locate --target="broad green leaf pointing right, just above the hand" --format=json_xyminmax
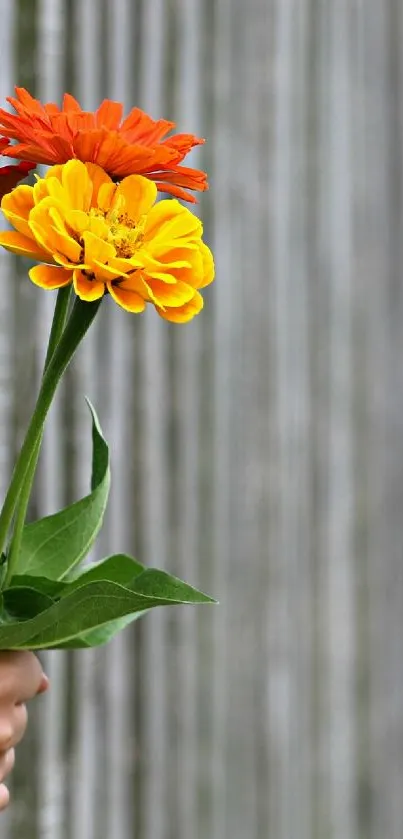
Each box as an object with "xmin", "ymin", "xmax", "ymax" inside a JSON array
[{"xmin": 0, "ymin": 555, "xmax": 214, "ymax": 650}]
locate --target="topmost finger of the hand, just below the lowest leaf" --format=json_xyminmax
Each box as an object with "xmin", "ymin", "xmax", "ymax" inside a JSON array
[{"xmin": 0, "ymin": 651, "xmax": 43, "ymax": 704}]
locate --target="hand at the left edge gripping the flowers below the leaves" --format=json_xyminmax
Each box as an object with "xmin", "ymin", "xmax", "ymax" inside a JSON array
[{"xmin": 0, "ymin": 652, "xmax": 49, "ymax": 810}]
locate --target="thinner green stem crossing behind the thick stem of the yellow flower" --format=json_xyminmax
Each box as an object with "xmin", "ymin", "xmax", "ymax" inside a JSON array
[{"xmin": 8, "ymin": 286, "xmax": 72, "ymax": 580}]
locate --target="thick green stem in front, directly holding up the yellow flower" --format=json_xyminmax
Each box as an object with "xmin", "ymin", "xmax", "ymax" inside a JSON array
[{"xmin": 0, "ymin": 297, "xmax": 101, "ymax": 588}]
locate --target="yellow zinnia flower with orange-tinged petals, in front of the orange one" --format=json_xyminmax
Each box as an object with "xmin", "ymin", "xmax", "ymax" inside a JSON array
[{"xmin": 0, "ymin": 160, "xmax": 214, "ymax": 323}]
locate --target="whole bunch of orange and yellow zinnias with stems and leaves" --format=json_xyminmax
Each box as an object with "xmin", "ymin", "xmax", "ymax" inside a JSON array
[{"xmin": 0, "ymin": 88, "xmax": 214, "ymax": 650}]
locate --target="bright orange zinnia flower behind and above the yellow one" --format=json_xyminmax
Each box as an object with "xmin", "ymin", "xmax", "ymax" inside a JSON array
[{"xmin": 0, "ymin": 87, "xmax": 207, "ymax": 203}]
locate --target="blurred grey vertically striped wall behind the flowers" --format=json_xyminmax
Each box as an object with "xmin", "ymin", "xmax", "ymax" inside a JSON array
[{"xmin": 0, "ymin": 0, "xmax": 403, "ymax": 839}]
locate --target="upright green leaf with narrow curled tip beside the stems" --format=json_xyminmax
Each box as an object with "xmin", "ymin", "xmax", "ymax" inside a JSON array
[{"xmin": 18, "ymin": 400, "xmax": 110, "ymax": 580}]
